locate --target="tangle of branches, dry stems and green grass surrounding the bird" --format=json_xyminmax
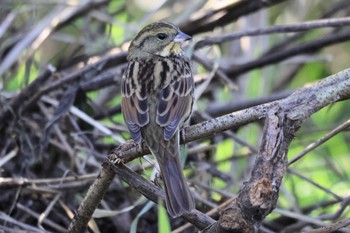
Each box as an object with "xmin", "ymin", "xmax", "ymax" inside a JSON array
[{"xmin": 0, "ymin": 0, "xmax": 350, "ymax": 233}]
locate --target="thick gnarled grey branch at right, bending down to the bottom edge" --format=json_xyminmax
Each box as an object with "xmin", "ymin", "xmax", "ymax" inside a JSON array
[{"xmin": 204, "ymin": 69, "xmax": 350, "ymax": 233}]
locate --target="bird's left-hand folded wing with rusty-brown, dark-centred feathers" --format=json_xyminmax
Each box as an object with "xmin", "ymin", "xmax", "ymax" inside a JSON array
[{"xmin": 121, "ymin": 64, "xmax": 149, "ymax": 143}]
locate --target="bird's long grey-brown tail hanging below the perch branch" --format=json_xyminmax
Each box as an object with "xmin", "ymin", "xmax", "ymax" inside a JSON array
[{"xmin": 159, "ymin": 155, "xmax": 195, "ymax": 217}]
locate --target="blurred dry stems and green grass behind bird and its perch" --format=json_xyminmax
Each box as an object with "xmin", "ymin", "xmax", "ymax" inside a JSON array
[{"xmin": 0, "ymin": 0, "xmax": 350, "ymax": 232}]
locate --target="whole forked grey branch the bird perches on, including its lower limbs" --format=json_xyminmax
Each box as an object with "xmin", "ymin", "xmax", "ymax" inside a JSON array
[{"xmin": 69, "ymin": 69, "xmax": 350, "ymax": 232}]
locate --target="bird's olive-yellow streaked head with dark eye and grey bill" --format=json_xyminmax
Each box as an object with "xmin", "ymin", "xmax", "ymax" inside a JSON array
[{"xmin": 129, "ymin": 22, "xmax": 191, "ymax": 57}]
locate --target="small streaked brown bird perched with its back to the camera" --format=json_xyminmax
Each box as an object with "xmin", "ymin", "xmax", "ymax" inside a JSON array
[{"xmin": 121, "ymin": 22, "xmax": 195, "ymax": 217}]
